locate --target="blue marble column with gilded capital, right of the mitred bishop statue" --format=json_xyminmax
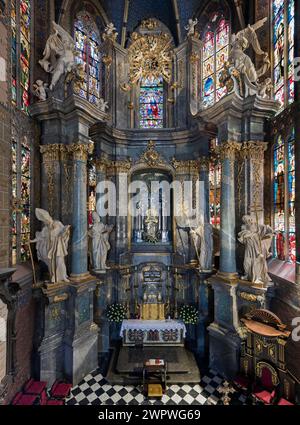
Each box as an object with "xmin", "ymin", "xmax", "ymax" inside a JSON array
[{"xmin": 67, "ymin": 143, "xmax": 92, "ymax": 280}]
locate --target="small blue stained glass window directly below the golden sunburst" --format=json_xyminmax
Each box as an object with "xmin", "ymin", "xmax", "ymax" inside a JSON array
[{"xmin": 140, "ymin": 77, "xmax": 164, "ymax": 128}]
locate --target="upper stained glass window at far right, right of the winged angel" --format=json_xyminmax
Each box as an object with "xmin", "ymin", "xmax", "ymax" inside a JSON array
[{"xmin": 273, "ymin": 0, "xmax": 295, "ymax": 107}]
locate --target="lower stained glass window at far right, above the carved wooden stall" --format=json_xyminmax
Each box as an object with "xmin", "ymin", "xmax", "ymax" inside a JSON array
[{"xmin": 273, "ymin": 131, "xmax": 296, "ymax": 262}]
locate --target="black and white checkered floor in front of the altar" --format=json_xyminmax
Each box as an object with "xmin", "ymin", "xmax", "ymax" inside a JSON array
[{"xmin": 66, "ymin": 370, "xmax": 246, "ymax": 405}]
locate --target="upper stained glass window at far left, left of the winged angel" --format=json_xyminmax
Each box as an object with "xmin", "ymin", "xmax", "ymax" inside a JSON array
[{"xmin": 11, "ymin": 0, "xmax": 31, "ymax": 113}]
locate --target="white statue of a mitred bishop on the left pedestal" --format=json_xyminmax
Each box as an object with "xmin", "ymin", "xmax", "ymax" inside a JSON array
[{"xmin": 32, "ymin": 208, "xmax": 71, "ymax": 283}]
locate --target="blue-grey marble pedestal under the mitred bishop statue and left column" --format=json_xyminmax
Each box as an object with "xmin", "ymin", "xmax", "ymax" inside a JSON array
[{"xmin": 33, "ymin": 276, "xmax": 98, "ymax": 385}]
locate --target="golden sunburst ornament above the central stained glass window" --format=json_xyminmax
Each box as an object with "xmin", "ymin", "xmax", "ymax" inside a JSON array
[{"xmin": 128, "ymin": 32, "xmax": 172, "ymax": 84}]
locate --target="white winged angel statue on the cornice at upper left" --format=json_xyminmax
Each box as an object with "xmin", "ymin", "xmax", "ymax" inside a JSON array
[{"xmin": 39, "ymin": 21, "xmax": 76, "ymax": 90}]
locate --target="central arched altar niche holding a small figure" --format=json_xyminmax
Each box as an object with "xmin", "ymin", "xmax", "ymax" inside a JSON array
[{"xmin": 131, "ymin": 170, "xmax": 173, "ymax": 248}]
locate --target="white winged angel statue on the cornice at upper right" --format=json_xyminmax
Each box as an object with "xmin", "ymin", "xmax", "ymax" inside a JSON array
[{"xmin": 229, "ymin": 18, "xmax": 271, "ymax": 85}]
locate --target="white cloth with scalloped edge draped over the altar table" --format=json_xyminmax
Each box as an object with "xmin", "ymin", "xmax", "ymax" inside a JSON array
[{"xmin": 120, "ymin": 319, "xmax": 186, "ymax": 338}]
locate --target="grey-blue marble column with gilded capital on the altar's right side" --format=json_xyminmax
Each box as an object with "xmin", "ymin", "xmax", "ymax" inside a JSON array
[{"xmin": 219, "ymin": 141, "xmax": 240, "ymax": 277}]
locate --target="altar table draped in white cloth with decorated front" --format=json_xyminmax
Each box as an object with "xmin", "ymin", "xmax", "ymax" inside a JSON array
[{"xmin": 120, "ymin": 319, "xmax": 186, "ymax": 346}]
